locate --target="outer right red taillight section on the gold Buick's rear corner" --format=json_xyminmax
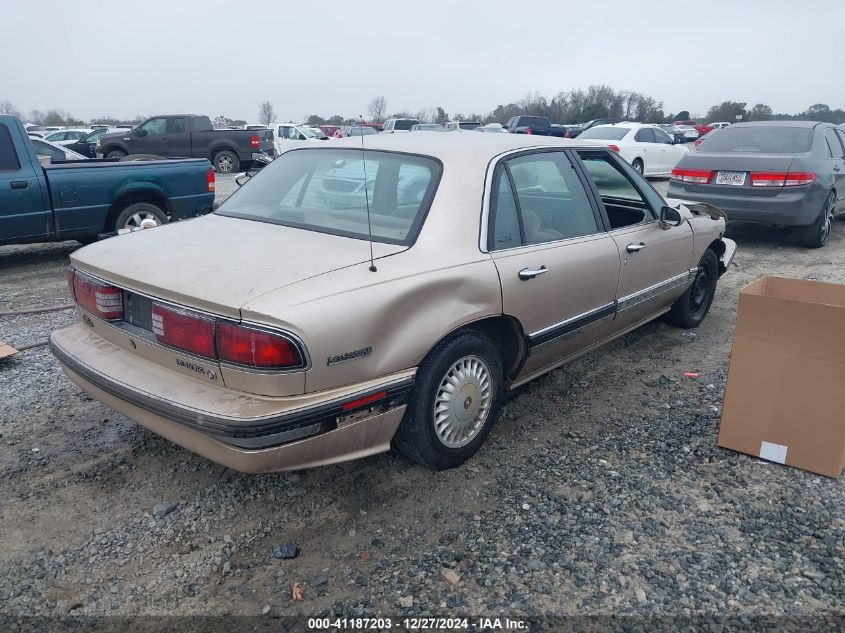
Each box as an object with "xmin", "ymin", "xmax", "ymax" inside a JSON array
[{"xmin": 217, "ymin": 321, "xmax": 303, "ymax": 369}]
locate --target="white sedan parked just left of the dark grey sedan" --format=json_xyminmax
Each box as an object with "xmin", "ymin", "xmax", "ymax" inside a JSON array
[{"xmin": 578, "ymin": 123, "xmax": 689, "ymax": 176}]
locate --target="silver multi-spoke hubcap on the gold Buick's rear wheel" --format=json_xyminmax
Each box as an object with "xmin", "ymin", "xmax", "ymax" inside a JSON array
[{"xmin": 434, "ymin": 356, "xmax": 493, "ymax": 448}]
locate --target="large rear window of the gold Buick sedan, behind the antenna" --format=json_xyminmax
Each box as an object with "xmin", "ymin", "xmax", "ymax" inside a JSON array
[{"xmin": 216, "ymin": 149, "xmax": 441, "ymax": 245}]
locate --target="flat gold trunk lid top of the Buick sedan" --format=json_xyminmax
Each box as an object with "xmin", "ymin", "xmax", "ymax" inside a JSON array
[{"xmin": 71, "ymin": 215, "xmax": 405, "ymax": 318}]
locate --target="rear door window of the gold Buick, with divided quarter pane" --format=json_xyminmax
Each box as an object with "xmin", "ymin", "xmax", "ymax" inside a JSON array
[{"xmin": 488, "ymin": 152, "xmax": 599, "ymax": 250}]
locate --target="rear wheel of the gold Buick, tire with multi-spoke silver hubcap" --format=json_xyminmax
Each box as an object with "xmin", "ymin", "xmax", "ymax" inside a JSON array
[{"xmin": 393, "ymin": 330, "xmax": 504, "ymax": 470}]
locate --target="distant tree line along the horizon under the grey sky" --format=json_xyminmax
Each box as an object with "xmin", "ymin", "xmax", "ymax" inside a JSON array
[{"xmin": 6, "ymin": 84, "xmax": 845, "ymax": 127}]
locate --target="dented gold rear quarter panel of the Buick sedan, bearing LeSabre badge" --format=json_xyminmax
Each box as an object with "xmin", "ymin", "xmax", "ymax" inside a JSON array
[{"xmin": 241, "ymin": 249, "xmax": 502, "ymax": 392}]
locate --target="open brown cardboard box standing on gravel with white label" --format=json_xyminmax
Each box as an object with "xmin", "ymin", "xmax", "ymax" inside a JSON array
[{"xmin": 718, "ymin": 277, "xmax": 845, "ymax": 477}]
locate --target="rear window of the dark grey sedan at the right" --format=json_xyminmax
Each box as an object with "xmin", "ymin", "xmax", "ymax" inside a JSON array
[{"xmin": 698, "ymin": 125, "xmax": 813, "ymax": 154}]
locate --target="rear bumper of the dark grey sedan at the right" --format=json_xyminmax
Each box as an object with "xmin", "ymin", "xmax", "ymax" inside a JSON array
[{"xmin": 667, "ymin": 181, "xmax": 824, "ymax": 226}]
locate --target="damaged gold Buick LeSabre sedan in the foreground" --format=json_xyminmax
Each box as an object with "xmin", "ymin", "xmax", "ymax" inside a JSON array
[{"xmin": 50, "ymin": 132, "xmax": 736, "ymax": 472}]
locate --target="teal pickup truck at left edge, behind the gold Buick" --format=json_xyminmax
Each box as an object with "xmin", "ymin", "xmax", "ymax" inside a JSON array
[{"xmin": 0, "ymin": 115, "xmax": 214, "ymax": 245}]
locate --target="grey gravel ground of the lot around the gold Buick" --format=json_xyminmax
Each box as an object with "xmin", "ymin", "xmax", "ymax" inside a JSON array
[{"xmin": 0, "ymin": 176, "xmax": 845, "ymax": 622}]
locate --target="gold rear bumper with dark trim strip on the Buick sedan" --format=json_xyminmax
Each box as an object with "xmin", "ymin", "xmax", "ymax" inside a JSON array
[{"xmin": 50, "ymin": 323, "xmax": 413, "ymax": 473}]
